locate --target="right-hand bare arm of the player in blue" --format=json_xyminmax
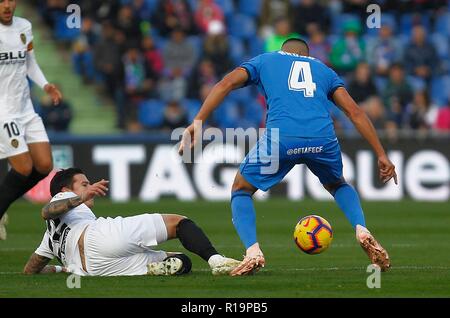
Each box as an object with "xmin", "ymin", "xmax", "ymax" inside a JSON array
[{"xmin": 333, "ymin": 87, "xmax": 397, "ymax": 184}]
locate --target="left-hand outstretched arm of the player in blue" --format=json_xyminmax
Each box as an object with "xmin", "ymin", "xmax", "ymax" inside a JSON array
[{"xmin": 178, "ymin": 68, "xmax": 248, "ymax": 154}]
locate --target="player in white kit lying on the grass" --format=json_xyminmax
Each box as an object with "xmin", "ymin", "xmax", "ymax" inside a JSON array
[{"xmin": 24, "ymin": 168, "xmax": 240, "ymax": 276}]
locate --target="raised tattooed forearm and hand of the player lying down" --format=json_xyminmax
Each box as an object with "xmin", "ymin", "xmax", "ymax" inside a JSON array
[{"xmin": 41, "ymin": 180, "xmax": 109, "ymax": 220}]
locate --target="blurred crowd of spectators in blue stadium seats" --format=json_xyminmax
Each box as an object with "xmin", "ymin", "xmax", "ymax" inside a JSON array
[{"xmin": 34, "ymin": 0, "xmax": 450, "ymax": 135}]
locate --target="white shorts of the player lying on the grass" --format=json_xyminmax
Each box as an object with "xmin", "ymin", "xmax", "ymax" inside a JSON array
[{"xmin": 84, "ymin": 214, "xmax": 167, "ymax": 276}]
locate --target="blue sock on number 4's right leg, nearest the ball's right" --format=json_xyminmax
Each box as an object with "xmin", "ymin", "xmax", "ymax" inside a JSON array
[{"xmin": 334, "ymin": 183, "xmax": 366, "ymax": 228}]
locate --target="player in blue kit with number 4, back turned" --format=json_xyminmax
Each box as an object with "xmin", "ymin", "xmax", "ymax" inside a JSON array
[{"xmin": 180, "ymin": 39, "xmax": 397, "ymax": 275}]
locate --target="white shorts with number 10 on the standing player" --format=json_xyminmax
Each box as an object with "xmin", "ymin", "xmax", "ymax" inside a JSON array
[{"xmin": 0, "ymin": 113, "xmax": 49, "ymax": 159}]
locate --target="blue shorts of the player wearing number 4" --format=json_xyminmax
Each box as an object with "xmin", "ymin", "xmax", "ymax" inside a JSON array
[{"xmin": 239, "ymin": 134, "xmax": 342, "ymax": 191}]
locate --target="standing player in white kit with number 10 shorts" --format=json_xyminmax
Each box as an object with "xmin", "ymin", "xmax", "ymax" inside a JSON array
[{"xmin": 0, "ymin": 0, "xmax": 61, "ymax": 240}]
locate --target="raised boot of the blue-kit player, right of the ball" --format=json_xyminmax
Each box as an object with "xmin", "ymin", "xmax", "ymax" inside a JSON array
[{"xmin": 356, "ymin": 224, "xmax": 391, "ymax": 272}]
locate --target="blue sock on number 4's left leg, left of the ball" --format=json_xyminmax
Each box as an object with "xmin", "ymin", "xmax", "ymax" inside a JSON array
[{"xmin": 231, "ymin": 191, "xmax": 257, "ymax": 248}]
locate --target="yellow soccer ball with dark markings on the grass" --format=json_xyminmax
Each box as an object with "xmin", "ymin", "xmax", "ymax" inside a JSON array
[{"xmin": 294, "ymin": 215, "xmax": 333, "ymax": 254}]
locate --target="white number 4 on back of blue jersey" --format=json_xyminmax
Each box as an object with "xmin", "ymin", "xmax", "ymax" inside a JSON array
[{"xmin": 289, "ymin": 61, "xmax": 316, "ymax": 97}]
